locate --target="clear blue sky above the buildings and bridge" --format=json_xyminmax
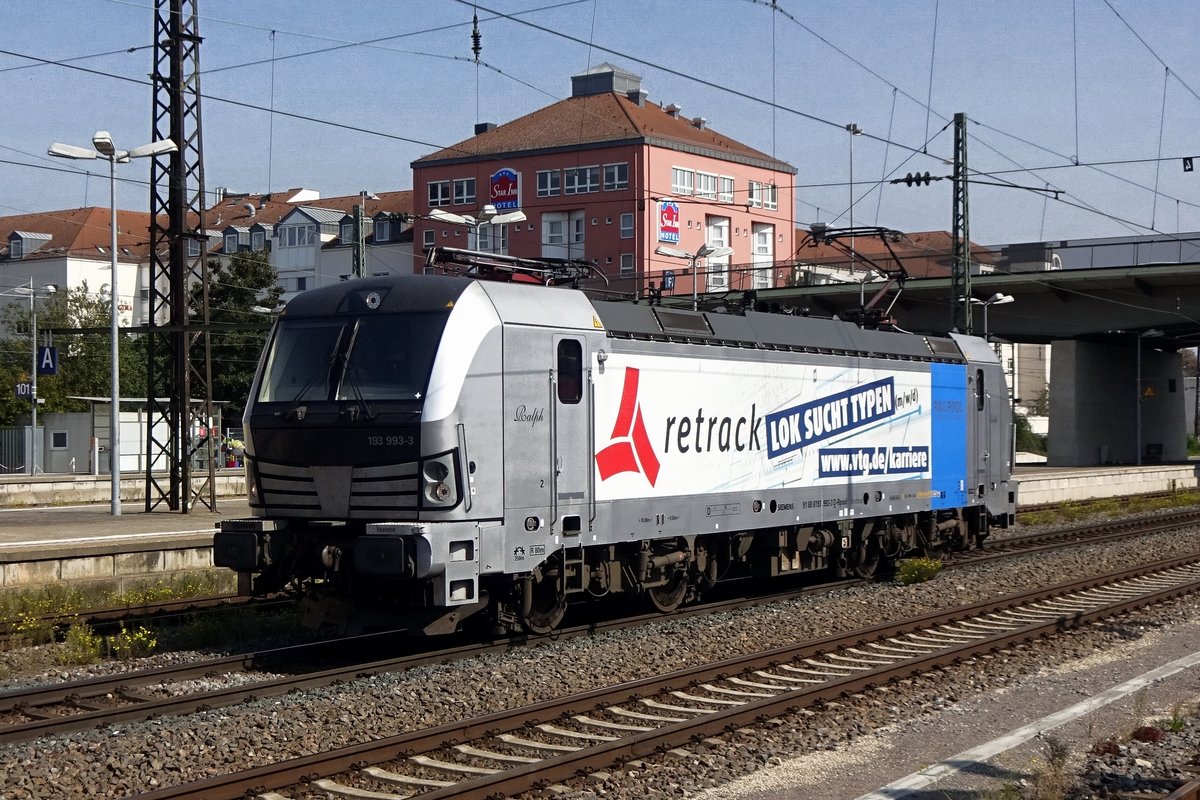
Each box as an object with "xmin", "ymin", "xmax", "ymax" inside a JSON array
[{"xmin": 0, "ymin": 0, "xmax": 1200, "ymax": 243}]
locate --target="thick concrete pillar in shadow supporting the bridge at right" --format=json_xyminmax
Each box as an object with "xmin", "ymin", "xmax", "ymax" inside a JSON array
[{"xmin": 1046, "ymin": 333, "xmax": 1188, "ymax": 467}]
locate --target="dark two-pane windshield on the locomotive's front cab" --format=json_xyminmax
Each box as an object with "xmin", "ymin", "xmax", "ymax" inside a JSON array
[{"xmin": 258, "ymin": 312, "xmax": 446, "ymax": 403}]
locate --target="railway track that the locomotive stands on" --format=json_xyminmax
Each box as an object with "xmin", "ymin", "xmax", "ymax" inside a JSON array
[{"xmin": 0, "ymin": 512, "xmax": 1200, "ymax": 744}]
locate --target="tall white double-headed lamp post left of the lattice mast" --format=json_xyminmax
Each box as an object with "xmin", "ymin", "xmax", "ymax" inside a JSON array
[{"xmin": 47, "ymin": 131, "xmax": 179, "ymax": 517}]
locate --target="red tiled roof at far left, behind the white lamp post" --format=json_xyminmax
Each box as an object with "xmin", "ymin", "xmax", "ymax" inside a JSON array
[{"xmin": 0, "ymin": 207, "xmax": 150, "ymax": 263}]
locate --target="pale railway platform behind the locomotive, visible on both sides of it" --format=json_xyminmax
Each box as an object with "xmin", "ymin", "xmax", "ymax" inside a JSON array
[{"xmin": 0, "ymin": 463, "xmax": 1200, "ymax": 590}]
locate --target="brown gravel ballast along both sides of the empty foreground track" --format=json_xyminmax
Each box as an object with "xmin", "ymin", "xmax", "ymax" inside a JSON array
[{"xmin": 0, "ymin": 513, "xmax": 1198, "ymax": 800}]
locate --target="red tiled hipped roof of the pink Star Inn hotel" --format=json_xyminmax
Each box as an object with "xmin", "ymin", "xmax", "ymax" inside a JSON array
[{"xmin": 413, "ymin": 92, "xmax": 794, "ymax": 172}]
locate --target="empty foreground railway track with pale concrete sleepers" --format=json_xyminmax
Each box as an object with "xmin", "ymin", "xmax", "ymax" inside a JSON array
[{"xmin": 124, "ymin": 553, "xmax": 1200, "ymax": 800}]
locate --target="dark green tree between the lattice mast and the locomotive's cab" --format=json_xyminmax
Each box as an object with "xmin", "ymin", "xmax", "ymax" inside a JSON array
[{"xmin": 193, "ymin": 251, "xmax": 283, "ymax": 425}]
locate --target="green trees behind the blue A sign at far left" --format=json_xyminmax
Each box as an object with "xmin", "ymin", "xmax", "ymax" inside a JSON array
[{"xmin": 0, "ymin": 282, "xmax": 145, "ymax": 425}]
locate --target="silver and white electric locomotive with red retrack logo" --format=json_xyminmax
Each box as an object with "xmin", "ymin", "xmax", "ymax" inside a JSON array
[{"xmin": 214, "ymin": 250, "xmax": 1015, "ymax": 633}]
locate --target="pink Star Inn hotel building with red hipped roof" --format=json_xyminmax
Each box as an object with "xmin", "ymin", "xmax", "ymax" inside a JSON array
[{"xmin": 412, "ymin": 64, "xmax": 796, "ymax": 294}]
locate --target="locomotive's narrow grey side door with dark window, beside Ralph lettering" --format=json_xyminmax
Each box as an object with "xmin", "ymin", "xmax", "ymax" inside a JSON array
[{"xmin": 550, "ymin": 336, "xmax": 595, "ymax": 536}]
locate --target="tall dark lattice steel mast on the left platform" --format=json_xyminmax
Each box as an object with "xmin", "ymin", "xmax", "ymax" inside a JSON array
[{"xmin": 145, "ymin": 0, "xmax": 216, "ymax": 513}]
